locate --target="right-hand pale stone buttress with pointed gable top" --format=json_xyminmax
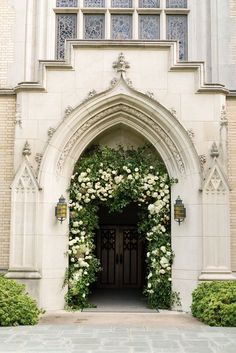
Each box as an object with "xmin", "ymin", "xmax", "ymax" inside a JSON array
[{"xmin": 200, "ymin": 158, "xmax": 234, "ymax": 280}]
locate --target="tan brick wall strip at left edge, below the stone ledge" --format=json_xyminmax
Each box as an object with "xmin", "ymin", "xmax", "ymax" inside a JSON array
[{"xmin": 0, "ymin": 95, "xmax": 15, "ymax": 270}]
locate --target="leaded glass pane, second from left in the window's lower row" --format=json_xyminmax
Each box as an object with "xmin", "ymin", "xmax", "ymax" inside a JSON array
[{"xmin": 84, "ymin": 14, "xmax": 105, "ymax": 39}]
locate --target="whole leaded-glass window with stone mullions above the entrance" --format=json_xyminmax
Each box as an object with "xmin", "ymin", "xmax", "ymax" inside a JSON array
[{"xmin": 54, "ymin": 0, "xmax": 189, "ymax": 60}]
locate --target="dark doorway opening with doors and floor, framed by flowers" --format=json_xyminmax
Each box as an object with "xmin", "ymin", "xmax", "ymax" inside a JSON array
[{"xmin": 88, "ymin": 204, "xmax": 149, "ymax": 312}]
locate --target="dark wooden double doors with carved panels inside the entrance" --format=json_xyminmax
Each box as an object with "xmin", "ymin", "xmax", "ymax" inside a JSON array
[{"xmin": 97, "ymin": 225, "xmax": 143, "ymax": 288}]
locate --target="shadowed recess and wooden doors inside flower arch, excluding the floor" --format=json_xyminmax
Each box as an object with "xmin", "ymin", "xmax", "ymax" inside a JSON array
[{"xmin": 96, "ymin": 204, "xmax": 145, "ymax": 289}]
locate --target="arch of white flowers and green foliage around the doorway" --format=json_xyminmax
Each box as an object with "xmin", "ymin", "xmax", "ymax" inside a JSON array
[{"xmin": 66, "ymin": 145, "xmax": 173, "ymax": 309}]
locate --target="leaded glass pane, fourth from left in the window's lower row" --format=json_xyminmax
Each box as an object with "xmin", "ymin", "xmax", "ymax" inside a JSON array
[{"xmin": 139, "ymin": 15, "xmax": 160, "ymax": 40}]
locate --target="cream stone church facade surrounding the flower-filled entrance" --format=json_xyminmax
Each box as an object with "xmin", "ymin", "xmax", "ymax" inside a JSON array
[{"xmin": 0, "ymin": 0, "xmax": 236, "ymax": 310}]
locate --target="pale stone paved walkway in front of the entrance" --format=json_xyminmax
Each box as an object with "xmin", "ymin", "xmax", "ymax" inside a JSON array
[{"xmin": 0, "ymin": 312, "xmax": 236, "ymax": 353}]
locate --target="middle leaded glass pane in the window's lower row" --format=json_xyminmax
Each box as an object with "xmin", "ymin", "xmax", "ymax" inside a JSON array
[{"xmin": 111, "ymin": 15, "xmax": 132, "ymax": 40}]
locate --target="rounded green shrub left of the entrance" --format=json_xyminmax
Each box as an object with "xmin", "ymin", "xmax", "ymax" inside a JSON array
[{"xmin": 0, "ymin": 276, "xmax": 42, "ymax": 326}]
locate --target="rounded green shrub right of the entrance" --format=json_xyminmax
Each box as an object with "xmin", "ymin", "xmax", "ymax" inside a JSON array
[{"xmin": 192, "ymin": 281, "xmax": 236, "ymax": 327}]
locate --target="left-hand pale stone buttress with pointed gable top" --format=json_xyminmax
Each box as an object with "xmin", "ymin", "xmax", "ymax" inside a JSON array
[{"xmin": 7, "ymin": 157, "xmax": 41, "ymax": 278}]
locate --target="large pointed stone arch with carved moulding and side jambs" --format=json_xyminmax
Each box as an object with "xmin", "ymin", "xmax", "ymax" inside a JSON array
[{"xmin": 30, "ymin": 77, "xmax": 205, "ymax": 310}]
